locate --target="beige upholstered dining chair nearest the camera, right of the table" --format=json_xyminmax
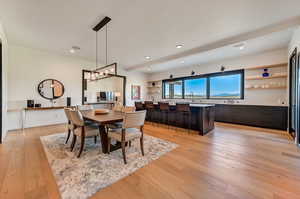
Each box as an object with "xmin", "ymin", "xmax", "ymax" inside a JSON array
[{"xmin": 107, "ymin": 110, "xmax": 146, "ymax": 164}]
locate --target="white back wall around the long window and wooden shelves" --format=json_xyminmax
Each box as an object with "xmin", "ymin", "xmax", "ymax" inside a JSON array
[{"xmin": 148, "ymin": 49, "xmax": 288, "ymax": 106}]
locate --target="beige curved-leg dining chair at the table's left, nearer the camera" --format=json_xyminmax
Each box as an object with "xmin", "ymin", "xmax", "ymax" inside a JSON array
[{"xmin": 69, "ymin": 110, "xmax": 99, "ymax": 158}]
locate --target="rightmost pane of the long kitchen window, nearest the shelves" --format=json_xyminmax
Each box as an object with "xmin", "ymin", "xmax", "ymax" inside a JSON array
[{"xmin": 209, "ymin": 74, "xmax": 242, "ymax": 99}]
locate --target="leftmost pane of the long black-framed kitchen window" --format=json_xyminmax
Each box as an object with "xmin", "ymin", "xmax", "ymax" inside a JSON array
[{"xmin": 163, "ymin": 80, "xmax": 182, "ymax": 99}]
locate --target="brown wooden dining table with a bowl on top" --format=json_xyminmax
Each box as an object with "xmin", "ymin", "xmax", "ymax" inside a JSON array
[{"xmin": 81, "ymin": 110, "xmax": 124, "ymax": 153}]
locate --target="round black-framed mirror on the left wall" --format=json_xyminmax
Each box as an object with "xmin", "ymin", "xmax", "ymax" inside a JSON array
[{"xmin": 38, "ymin": 79, "xmax": 65, "ymax": 100}]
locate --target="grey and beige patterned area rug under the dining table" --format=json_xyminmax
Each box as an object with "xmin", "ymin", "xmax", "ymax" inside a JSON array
[{"xmin": 40, "ymin": 133, "xmax": 177, "ymax": 199}]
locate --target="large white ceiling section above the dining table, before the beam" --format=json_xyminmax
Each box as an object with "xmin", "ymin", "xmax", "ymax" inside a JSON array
[{"xmin": 0, "ymin": 0, "xmax": 300, "ymax": 70}]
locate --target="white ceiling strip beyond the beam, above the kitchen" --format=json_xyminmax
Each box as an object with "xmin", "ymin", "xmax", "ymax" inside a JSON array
[{"xmin": 142, "ymin": 28, "xmax": 294, "ymax": 73}]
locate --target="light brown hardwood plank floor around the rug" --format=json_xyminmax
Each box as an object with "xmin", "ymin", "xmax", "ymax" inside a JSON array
[{"xmin": 0, "ymin": 123, "xmax": 300, "ymax": 199}]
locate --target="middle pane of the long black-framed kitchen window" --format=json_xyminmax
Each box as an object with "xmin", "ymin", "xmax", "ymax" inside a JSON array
[{"xmin": 184, "ymin": 78, "xmax": 207, "ymax": 99}]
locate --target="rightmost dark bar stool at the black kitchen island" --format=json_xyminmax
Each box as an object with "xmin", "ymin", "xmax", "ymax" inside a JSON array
[{"xmin": 176, "ymin": 103, "xmax": 192, "ymax": 132}]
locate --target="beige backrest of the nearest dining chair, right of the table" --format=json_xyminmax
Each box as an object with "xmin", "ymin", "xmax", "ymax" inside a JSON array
[{"xmin": 123, "ymin": 110, "xmax": 146, "ymax": 129}]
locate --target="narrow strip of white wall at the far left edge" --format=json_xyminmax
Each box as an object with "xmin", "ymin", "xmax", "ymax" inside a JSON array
[{"xmin": 0, "ymin": 23, "xmax": 8, "ymax": 140}]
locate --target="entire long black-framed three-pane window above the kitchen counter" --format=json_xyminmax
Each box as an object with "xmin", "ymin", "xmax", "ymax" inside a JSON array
[{"xmin": 163, "ymin": 70, "xmax": 244, "ymax": 99}]
